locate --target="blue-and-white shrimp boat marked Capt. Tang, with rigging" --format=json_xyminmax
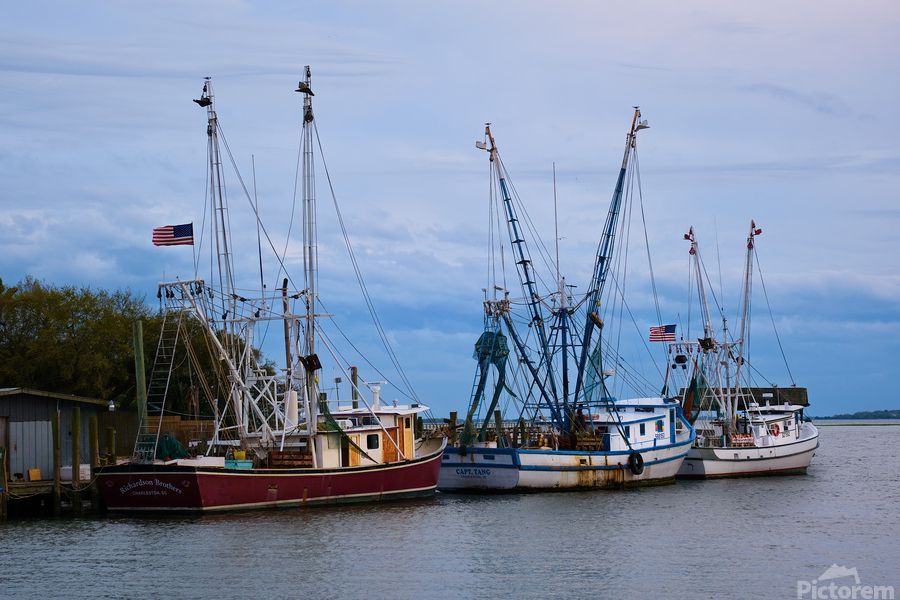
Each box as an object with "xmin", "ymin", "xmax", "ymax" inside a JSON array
[{"xmin": 438, "ymin": 108, "xmax": 694, "ymax": 492}]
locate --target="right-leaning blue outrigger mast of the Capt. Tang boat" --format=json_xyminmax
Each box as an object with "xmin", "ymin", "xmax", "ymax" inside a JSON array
[{"xmin": 574, "ymin": 106, "xmax": 649, "ymax": 400}]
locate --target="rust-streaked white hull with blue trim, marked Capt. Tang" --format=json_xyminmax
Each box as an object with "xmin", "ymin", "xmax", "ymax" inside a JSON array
[{"xmin": 438, "ymin": 435, "xmax": 693, "ymax": 493}]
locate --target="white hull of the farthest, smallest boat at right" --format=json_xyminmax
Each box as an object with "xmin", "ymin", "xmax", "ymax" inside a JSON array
[{"xmin": 677, "ymin": 433, "xmax": 819, "ymax": 479}]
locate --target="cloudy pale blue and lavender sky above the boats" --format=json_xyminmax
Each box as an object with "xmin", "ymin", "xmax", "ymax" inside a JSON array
[{"xmin": 0, "ymin": 0, "xmax": 900, "ymax": 415}]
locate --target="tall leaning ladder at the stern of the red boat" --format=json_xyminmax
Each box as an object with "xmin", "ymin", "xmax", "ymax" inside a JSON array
[{"xmin": 134, "ymin": 310, "xmax": 185, "ymax": 463}]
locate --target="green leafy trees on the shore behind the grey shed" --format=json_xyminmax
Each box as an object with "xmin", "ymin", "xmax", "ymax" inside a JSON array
[{"xmin": 0, "ymin": 277, "xmax": 250, "ymax": 415}]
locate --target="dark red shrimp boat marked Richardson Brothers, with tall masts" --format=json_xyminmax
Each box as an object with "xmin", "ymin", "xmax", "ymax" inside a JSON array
[{"xmin": 98, "ymin": 67, "xmax": 446, "ymax": 511}]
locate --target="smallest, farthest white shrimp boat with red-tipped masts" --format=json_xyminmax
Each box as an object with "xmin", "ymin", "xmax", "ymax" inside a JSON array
[{"xmin": 669, "ymin": 222, "xmax": 819, "ymax": 479}]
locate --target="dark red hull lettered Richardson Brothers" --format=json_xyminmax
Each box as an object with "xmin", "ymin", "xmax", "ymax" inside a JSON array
[{"xmin": 97, "ymin": 442, "xmax": 445, "ymax": 512}]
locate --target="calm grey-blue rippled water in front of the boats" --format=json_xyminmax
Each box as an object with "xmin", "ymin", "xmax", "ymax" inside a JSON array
[{"xmin": 0, "ymin": 426, "xmax": 900, "ymax": 599}]
